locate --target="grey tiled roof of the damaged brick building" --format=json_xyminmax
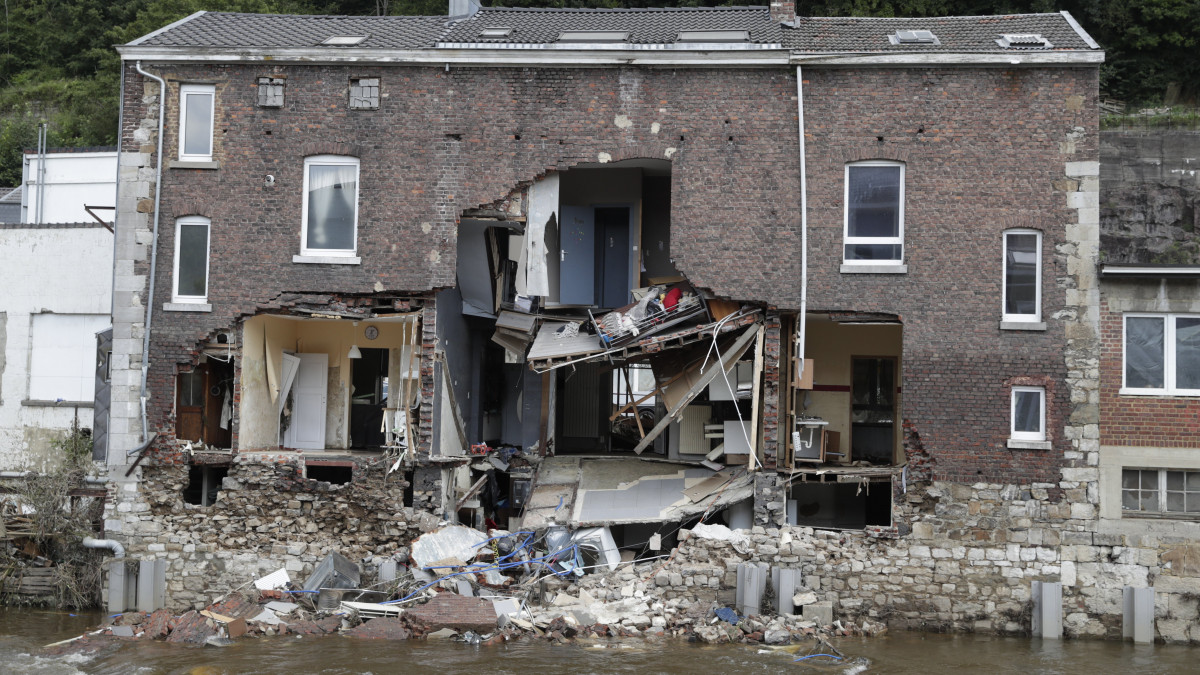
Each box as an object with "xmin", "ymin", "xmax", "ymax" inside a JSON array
[{"xmin": 124, "ymin": 7, "xmax": 1090, "ymax": 53}]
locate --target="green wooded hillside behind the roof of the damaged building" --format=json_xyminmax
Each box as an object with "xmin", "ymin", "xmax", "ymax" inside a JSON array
[{"xmin": 0, "ymin": 0, "xmax": 1200, "ymax": 185}]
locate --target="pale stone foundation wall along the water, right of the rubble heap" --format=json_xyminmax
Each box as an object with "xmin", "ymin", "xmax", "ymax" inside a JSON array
[{"xmin": 568, "ymin": 480, "xmax": 1200, "ymax": 643}]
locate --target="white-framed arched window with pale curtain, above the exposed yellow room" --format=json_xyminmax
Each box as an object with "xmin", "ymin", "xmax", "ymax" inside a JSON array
[{"xmin": 300, "ymin": 155, "xmax": 359, "ymax": 257}]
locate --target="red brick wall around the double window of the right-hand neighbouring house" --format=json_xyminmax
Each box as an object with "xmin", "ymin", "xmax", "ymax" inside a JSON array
[{"xmin": 1100, "ymin": 294, "xmax": 1200, "ymax": 448}]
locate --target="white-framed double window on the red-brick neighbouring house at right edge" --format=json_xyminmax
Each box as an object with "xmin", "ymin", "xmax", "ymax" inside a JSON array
[{"xmin": 1121, "ymin": 313, "xmax": 1200, "ymax": 396}]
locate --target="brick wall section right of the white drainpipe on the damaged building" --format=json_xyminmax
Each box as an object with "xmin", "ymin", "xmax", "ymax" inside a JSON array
[{"xmin": 804, "ymin": 68, "xmax": 1098, "ymax": 482}]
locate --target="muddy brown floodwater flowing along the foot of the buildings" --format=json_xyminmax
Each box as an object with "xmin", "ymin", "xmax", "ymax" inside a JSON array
[{"xmin": 0, "ymin": 609, "xmax": 1200, "ymax": 675}]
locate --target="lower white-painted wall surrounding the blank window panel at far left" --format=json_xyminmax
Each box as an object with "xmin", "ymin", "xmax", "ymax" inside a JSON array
[{"xmin": 0, "ymin": 226, "xmax": 113, "ymax": 471}]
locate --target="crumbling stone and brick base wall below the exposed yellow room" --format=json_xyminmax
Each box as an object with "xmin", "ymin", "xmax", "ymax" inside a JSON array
[{"xmin": 106, "ymin": 453, "xmax": 438, "ymax": 609}]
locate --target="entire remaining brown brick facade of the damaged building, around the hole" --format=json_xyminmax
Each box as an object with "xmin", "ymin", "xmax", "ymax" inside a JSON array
[{"xmin": 124, "ymin": 57, "xmax": 1097, "ymax": 480}]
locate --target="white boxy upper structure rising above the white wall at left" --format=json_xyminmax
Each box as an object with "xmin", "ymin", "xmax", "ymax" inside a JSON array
[{"xmin": 22, "ymin": 150, "xmax": 116, "ymax": 223}]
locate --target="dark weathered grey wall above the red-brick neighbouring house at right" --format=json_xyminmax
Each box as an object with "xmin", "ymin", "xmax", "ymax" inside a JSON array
[{"xmin": 1100, "ymin": 129, "xmax": 1200, "ymax": 264}]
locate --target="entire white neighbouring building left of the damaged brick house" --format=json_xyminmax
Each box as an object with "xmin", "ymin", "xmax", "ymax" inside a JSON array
[{"xmin": 0, "ymin": 151, "xmax": 116, "ymax": 471}]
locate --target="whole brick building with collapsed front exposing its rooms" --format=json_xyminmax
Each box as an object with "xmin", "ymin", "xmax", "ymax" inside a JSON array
[{"xmin": 107, "ymin": 0, "xmax": 1142, "ymax": 634}]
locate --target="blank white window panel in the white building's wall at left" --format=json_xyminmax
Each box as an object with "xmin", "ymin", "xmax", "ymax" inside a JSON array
[{"xmin": 29, "ymin": 313, "xmax": 110, "ymax": 404}]
